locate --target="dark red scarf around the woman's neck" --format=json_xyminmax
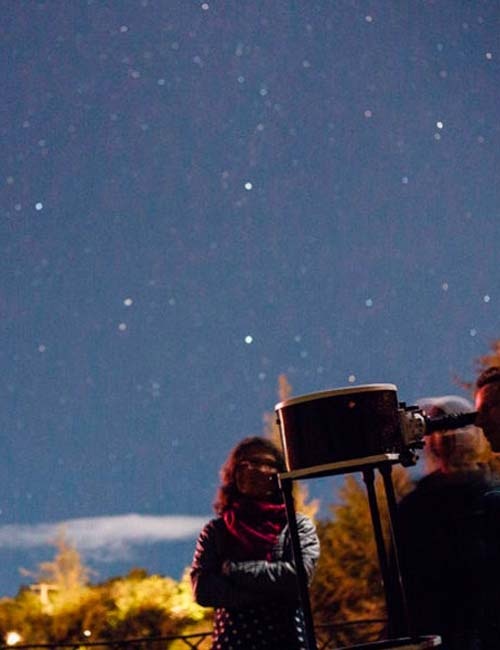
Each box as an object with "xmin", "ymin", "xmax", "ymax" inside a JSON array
[{"xmin": 222, "ymin": 499, "xmax": 286, "ymax": 560}]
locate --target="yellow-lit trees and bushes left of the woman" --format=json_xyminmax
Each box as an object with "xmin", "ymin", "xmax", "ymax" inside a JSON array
[{"xmin": 0, "ymin": 535, "xmax": 210, "ymax": 644}]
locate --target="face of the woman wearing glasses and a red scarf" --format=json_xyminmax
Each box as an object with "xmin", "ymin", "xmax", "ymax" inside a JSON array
[{"xmin": 235, "ymin": 447, "xmax": 278, "ymax": 499}]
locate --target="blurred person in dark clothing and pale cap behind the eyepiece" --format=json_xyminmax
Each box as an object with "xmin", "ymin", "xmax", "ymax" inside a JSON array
[{"xmin": 398, "ymin": 396, "xmax": 500, "ymax": 650}]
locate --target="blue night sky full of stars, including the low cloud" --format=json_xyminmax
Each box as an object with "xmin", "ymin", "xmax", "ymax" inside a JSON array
[{"xmin": 0, "ymin": 0, "xmax": 500, "ymax": 595}]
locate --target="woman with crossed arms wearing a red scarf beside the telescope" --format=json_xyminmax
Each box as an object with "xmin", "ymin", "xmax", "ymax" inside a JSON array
[{"xmin": 191, "ymin": 437, "xmax": 319, "ymax": 650}]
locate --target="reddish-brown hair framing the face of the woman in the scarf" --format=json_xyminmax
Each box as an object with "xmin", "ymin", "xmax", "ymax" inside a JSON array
[{"xmin": 214, "ymin": 436, "xmax": 286, "ymax": 515}]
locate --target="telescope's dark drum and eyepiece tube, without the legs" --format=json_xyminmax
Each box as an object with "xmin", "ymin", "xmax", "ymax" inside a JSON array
[{"xmin": 275, "ymin": 384, "xmax": 477, "ymax": 471}]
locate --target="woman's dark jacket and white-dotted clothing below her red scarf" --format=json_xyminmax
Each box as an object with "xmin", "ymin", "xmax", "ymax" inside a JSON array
[{"xmin": 191, "ymin": 514, "xmax": 319, "ymax": 650}]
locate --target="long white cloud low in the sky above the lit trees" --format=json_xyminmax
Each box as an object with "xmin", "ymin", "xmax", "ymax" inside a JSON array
[{"xmin": 0, "ymin": 514, "xmax": 208, "ymax": 561}]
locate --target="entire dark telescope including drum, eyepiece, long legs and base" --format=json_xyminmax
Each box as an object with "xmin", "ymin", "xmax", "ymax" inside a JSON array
[{"xmin": 275, "ymin": 384, "xmax": 458, "ymax": 650}]
